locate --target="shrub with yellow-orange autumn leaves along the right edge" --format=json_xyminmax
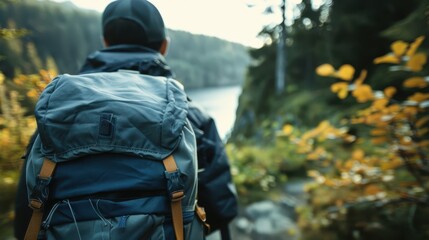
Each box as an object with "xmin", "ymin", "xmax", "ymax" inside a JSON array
[{"xmin": 283, "ymin": 37, "xmax": 429, "ymax": 240}]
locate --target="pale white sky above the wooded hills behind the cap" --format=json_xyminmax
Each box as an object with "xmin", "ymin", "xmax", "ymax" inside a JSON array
[{"xmin": 50, "ymin": 0, "xmax": 300, "ymax": 47}]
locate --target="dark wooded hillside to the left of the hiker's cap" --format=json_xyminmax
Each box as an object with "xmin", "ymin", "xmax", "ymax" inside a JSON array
[{"xmin": 0, "ymin": 1, "xmax": 102, "ymax": 78}]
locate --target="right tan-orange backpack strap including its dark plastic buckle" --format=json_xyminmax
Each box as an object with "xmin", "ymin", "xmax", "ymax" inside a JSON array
[{"xmin": 162, "ymin": 155, "xmax": 185, "ymax": 240}]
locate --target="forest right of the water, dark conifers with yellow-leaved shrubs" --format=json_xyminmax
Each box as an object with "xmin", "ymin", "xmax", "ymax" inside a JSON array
[{"xmin": 228, "ymin": 0, "xmax": 429, "ymax": 240}]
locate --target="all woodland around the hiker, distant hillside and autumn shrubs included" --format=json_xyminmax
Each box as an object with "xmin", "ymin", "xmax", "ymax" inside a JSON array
[{"xmin": 0, "ymin": 0, "xmax": 429, "ymax": 240}]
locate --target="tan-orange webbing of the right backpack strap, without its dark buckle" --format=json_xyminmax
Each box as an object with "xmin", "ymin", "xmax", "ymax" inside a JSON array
[{"xmin": 162, "ymin": 155, "xmax": 185, "ymax": 240}]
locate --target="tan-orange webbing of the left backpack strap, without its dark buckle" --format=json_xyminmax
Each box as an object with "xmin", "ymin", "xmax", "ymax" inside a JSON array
[{"xmin": 24, "ymin": 158, "xmax": 56, "ymax": 240}]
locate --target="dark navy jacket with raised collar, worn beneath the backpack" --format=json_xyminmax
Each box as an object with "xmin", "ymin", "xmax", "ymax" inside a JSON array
[{"xmin": 15, "ymin": 45, "xmax": 238, "ymax": 239}]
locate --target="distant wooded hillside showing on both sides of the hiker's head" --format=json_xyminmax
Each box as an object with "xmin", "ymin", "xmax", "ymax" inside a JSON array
[{"xmin": 0, "ymin": 0, "xmax": 249, "ymax": 88}]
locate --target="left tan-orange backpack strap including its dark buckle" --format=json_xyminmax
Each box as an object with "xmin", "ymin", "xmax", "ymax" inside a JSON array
[{"xmin": 24, "ymin": 158, "xmax": 56, "ymax": 240}]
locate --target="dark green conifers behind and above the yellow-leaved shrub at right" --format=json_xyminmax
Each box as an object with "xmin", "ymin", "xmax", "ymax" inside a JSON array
[{"xmin": 231, "ymin": 0, "xmax": 422, "ymax": 141}]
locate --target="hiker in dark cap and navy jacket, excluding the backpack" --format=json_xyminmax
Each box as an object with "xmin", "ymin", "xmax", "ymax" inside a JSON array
[{"xmin": 14, "ymin": 0, "xmax": 238, "ymax": 240}]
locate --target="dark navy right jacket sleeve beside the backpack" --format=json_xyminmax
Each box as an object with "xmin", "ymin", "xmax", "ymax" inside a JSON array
[{"xmin": 188, "ymin": 102, "xmax": 238, "ymax": 230}]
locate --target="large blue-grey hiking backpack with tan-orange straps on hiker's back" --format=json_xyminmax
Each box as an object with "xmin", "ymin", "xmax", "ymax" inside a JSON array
[{"xmin": 25, "ymin": 71, "xmax": 206, "ymax": 240}]
